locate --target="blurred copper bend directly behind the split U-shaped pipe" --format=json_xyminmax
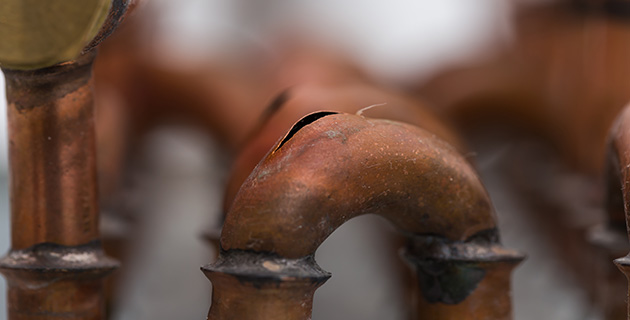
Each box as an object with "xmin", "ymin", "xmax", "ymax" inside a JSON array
[{"xmin": 220, "ymin": 79, "xmax": 465, "ymax": 234}]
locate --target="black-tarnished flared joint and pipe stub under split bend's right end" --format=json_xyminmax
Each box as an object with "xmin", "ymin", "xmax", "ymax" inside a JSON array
[{"xmin": 405, "ymin": 232, "xmax": 523, "ymax": 320}]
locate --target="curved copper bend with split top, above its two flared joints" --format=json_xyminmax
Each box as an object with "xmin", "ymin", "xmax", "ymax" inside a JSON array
[{"xmin": 221, "ymin": 112, "xmax": 496, "ymax": 258}]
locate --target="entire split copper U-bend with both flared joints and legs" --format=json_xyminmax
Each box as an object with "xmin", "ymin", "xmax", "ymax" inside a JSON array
[{"xmin": 202, "ymin": 112, "xmax": 522, "ymax": 320}]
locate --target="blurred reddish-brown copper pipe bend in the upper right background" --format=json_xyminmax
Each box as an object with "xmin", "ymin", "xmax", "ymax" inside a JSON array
[{"xmin": 419, "ymin": 0, "xmax": 630, "ymax": 177}]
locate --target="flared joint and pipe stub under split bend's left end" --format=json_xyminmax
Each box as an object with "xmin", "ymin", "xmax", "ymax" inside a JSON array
[{"xmin": 201, "ymin": 250, "xmax": 330, "ymax": 320}]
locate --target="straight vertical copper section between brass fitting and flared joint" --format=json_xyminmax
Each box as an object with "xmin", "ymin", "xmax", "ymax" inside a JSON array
[{"xmin": 5, "ymin": 54, "xmax": 98, "ymax": 250}]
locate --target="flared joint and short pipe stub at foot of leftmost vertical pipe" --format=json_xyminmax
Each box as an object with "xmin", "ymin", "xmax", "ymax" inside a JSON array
[{"xmin": 0, "ymin": 241, "xmax": 118, "ymax": 320}]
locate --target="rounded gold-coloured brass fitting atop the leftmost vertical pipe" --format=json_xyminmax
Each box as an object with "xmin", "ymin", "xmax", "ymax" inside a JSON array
[{"xmin": 0, "ymin": 0, "xmax": 111, "ymax": 69}]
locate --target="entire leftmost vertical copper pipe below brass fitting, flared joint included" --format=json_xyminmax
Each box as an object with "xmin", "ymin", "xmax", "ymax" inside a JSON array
[{"xmin": 0, "ymin": 0, "xmax": 128, "ymax": 320}]
